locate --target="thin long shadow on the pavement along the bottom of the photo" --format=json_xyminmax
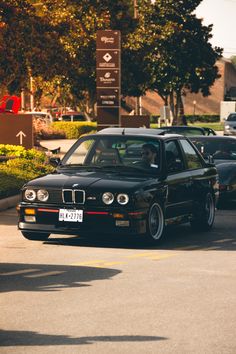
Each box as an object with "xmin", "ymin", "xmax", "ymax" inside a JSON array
[{"xmin": 0, "ymin": 330, "xmax": 168, "ymax": 347}]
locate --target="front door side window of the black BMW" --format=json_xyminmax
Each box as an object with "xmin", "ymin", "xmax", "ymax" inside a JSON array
[{"xmin": 165, "ymin": 140, "xmax": 184, "ymax": 173}]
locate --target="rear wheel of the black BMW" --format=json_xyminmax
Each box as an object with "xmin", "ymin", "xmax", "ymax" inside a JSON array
[{"xmin": 190, "ymin": 192, "xmax": 215, "ymax": 231}]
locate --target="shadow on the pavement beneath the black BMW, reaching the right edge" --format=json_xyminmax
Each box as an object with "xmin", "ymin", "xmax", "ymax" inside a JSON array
[{"xmin": 44, "ymin": 211, "xmax": 236, "ymax": 251}]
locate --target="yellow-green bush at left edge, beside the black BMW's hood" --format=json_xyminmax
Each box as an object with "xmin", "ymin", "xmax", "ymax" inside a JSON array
[{"xmin": 0, "ymin": 144, "xmax": 54, "ymax": 199}]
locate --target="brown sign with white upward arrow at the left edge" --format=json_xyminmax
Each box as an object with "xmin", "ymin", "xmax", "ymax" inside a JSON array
[{"xmin": 0, "ymin": 113, "xmax": 33, "ymax": 149}]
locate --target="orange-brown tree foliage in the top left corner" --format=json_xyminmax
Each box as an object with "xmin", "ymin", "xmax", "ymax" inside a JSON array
[{"xmin": 0, "ymin": 0, "xmax": 69, "ymax": 93}]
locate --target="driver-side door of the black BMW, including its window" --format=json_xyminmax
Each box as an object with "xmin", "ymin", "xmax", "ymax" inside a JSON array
[{"xmin": 164, "ymin": 139, "xmax": 192, "ymax": 219}]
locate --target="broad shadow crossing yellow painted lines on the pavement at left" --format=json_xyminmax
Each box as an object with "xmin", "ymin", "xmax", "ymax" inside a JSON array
[{"xmin": 0, "ymin": 263, "xmax": 121, "ymax": 293}]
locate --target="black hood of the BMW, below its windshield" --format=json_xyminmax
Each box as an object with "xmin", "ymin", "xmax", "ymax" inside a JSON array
[{"xmin": 25, "ymin": 171, "xmax": 157, "ymax": 191}]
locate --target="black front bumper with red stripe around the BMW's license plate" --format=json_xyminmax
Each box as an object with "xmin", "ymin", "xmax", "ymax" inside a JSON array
[{"xmin": 17, "ymin": 203, "xmax": 147, "ymax": 235}]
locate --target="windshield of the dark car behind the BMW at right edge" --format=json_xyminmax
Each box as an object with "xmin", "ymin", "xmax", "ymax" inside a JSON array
[{"xmin": 191, "ymin": 139, "xmax": 236, "ymax": 160}]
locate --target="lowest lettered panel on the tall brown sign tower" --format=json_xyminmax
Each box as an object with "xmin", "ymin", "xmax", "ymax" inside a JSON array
[{"xmin": 97, "ymin": 88, "xmax": 120, "ymax": 107}]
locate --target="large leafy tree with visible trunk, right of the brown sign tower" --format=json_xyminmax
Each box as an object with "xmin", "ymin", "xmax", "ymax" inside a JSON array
[{"xmin": 142, "ymin": 0, "xmax": 222, "ymax": 123}]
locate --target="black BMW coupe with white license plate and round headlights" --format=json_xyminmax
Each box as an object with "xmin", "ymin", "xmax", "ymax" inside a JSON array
[{"xmin": 18, "ymin": 128, "xmax": 218, "ymax": 241}]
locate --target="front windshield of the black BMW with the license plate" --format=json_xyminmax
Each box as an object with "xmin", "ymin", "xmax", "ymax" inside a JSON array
[{"xmin": 61, "ymin": 135, "xmax": 160, "ymax": 173}]
